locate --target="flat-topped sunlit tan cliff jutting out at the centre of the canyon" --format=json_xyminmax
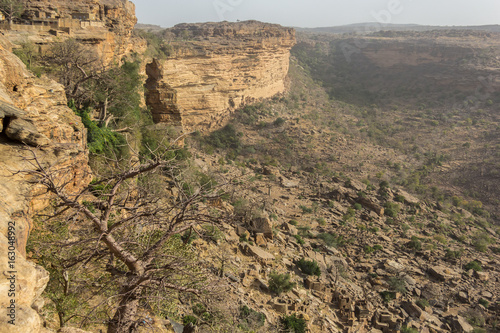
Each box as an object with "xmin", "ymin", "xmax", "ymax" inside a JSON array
[{"xmin": 146, "ymin": 21, "xmax": 295, "ymax": 130}]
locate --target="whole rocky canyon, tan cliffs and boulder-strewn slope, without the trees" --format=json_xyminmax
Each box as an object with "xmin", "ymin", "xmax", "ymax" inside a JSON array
[{"xmin": 0, "ymin": 0, "xmax": 500, "ymax": 333}]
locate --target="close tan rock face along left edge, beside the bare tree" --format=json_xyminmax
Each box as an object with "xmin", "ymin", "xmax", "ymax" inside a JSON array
[{"xmin": 0, "ymin": 37, "xmax": 90, "ymax": 333}]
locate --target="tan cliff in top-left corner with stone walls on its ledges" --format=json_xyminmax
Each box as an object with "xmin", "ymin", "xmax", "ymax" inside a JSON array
[{"xmin": 5, "ymin": 0, "xmax": 145, "ymax": 64}]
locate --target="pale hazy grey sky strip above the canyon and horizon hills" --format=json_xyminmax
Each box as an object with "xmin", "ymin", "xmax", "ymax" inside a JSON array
[{"xmin": 132, "ymin": 0, "xmax": 500, "ymax": 27}]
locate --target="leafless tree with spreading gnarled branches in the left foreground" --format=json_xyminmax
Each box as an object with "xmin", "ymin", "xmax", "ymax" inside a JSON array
[{"xmin": 23, "ymin": 141, "xmax": 227, "ymax": 333}]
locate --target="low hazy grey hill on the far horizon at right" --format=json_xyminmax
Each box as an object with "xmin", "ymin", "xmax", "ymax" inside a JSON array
[{"xmin": 295, "ymin": 22, "xmax": 500, "ymax": 34}]
